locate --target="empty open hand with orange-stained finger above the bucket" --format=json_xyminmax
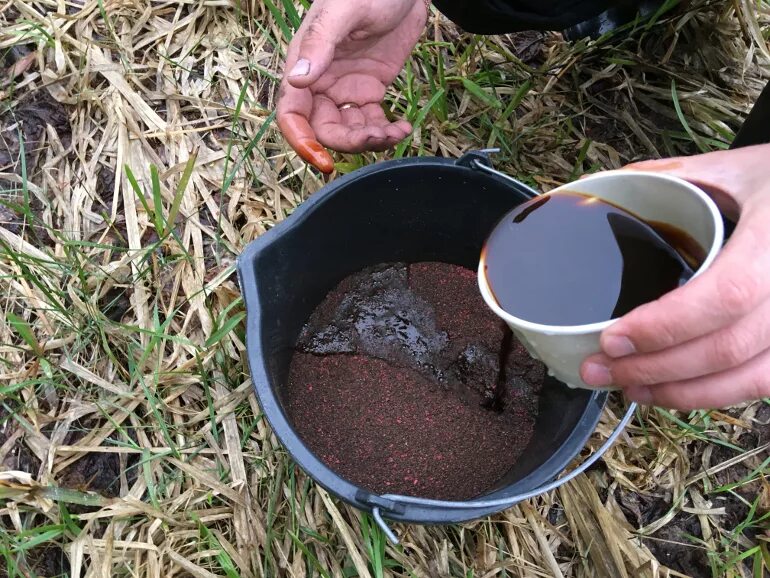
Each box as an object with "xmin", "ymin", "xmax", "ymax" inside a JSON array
[{"xmin": 277, "ymin": 0, "xmax": 427, "ymax": 173}]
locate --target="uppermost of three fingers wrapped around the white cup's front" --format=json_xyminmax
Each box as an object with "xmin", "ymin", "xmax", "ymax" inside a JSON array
[{"xmin": 600, "ymin": 199, "xmax": 770, "ymax": 358}]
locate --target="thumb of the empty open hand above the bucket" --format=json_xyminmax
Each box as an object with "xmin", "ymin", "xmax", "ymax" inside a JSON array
[{"xmin": 287, "ymin": 1, "xmax": 361, "ymax": 88}]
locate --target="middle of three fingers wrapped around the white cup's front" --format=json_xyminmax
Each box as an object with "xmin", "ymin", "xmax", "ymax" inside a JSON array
[{"xmin": 582, "ymin": 300, "xmax": 770, "ymax": 388}]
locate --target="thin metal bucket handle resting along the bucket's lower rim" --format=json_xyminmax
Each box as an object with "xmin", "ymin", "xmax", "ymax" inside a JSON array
[{"xmin": 372, "ymin": 402, "xmax": 637, "ymax": 545}]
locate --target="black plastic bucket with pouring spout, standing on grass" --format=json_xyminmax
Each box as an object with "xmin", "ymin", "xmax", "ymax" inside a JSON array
[{"xmin": 238, "ymin": 153, "xmax": 624, "ymax": 524}]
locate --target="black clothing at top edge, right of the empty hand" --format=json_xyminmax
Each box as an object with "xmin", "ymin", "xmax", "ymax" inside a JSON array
[{"xmin": 433, "ymin": 0, "xmax": 610, "ymax": 34}]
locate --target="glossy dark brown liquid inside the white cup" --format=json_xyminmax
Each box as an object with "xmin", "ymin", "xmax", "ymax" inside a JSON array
[{"xmin": 482, "ymin": 192, "xmax": 706, "ymax": 325}]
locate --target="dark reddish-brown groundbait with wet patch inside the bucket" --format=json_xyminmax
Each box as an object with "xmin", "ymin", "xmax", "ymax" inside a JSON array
[{"xmin": 284, "ymin": 263, "xmax": 544, "ymax": 500}]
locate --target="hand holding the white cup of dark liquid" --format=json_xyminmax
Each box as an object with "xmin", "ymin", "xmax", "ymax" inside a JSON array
[{"xmin": 581, "ymin": 145, "xmax": 770, "ymax": 410}]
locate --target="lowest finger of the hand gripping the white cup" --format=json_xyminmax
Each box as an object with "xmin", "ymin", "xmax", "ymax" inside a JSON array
[{"xmin": 625, "ymin": 351, "xmax": 770, "ymax": 411}]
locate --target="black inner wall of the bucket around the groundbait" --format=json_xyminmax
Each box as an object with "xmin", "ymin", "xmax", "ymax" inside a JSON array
[{"xmin": 242, "ymin": 159, "xmax": 604, "ymax": 519}]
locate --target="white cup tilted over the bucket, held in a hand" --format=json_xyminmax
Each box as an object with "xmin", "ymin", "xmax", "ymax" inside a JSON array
[{"xmin": 478, "ymin": 170, "xmax": 724, "ymax": 389}]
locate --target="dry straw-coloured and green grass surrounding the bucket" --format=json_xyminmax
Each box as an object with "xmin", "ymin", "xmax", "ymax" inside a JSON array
[{"xmin": 0, "ymin": 0, "xmax": 770, "ymax": 578}]
